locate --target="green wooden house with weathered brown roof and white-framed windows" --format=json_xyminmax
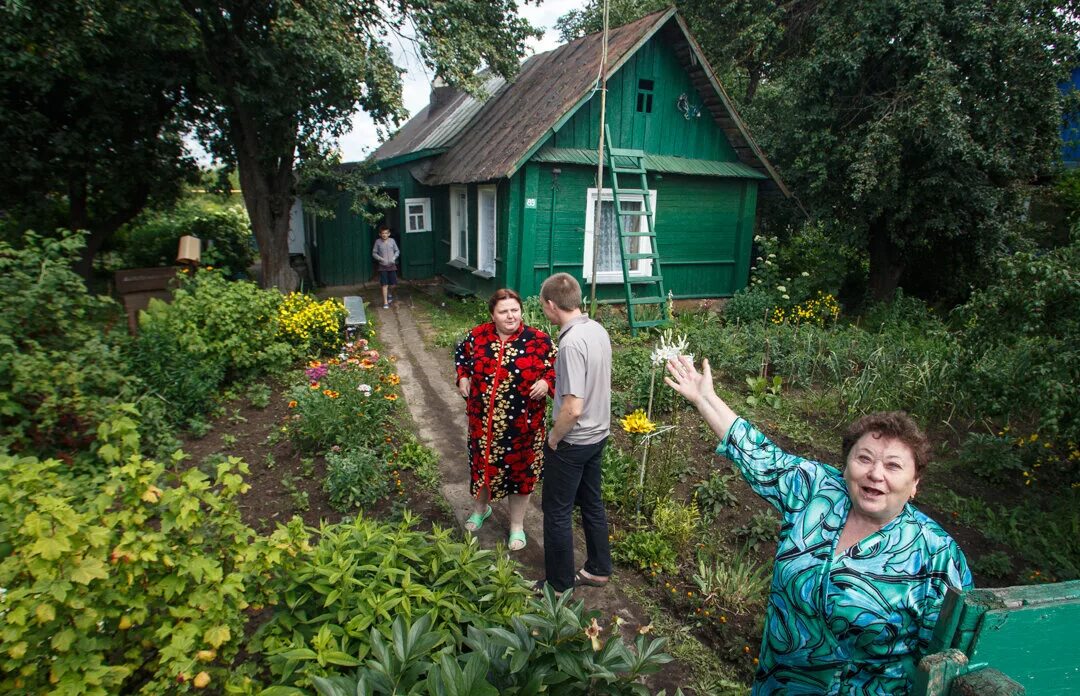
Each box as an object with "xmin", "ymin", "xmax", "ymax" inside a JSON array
[{"xmin": 308, "ymin": 9, "xmax": 787, "ymax": 299}]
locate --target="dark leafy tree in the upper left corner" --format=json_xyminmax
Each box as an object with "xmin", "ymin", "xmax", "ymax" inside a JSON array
[{"xmin": 0, "ymin": 0, "xmax": 195, "ymax": 278}]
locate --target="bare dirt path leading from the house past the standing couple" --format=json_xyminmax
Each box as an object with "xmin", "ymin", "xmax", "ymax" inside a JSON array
[{"xmin": 334, "ymin": 285, "xmax": 648, "ymax": 629}]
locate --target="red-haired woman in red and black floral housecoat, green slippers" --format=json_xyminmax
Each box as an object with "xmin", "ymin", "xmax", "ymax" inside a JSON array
[{"xmin": 456, "ymin": 290, "xmax": 555, "ymax": 551}]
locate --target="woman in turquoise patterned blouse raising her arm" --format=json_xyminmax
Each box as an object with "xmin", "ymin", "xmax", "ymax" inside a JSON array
[{"xmin": 665, "ymin": 357, "xmax": 972, "ymax": 695}]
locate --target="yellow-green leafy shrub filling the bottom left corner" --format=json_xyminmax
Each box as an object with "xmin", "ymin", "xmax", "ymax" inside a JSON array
[{"xmin": 0, "ymin": 420, "xmax": 293, "ymax": 694}]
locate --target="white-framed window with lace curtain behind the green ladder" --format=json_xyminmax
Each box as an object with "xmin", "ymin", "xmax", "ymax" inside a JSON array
[{"xmin": 583, "ymin": 188, "xmax": 657, "ymax": 283}]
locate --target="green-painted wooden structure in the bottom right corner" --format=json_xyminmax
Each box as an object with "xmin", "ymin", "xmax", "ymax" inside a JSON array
[{"xmin": 913, "ymin": 580, "xmax": 1080, "ymax": 696}]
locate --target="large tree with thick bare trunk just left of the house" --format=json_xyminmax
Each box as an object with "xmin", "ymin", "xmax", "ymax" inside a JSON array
[{"xmin": 178, "ymin": 0, "xmax": 544, "ymax": 290}]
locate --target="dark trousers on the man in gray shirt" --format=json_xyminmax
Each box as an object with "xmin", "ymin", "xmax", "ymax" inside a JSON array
[{"xmin": 541, "ymin": 438, "xmax": 611, "ymax": 592}]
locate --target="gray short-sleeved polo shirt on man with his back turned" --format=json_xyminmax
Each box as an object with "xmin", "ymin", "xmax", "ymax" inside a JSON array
[{"xmin": 552, "ymin": 314, "xmax": 611, "ymax": 444}]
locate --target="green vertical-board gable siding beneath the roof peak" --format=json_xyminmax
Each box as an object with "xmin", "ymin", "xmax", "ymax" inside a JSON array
[{"xmin": 548, "ymin": 37, "xmax": 739, "ymax": 162}]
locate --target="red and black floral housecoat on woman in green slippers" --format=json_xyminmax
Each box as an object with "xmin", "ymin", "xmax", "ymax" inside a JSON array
[{"xmin": 455, "ymin": 322, "xmax": 556, "ymax": 500}]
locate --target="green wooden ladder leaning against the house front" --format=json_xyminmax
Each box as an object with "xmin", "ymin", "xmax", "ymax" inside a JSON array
[{"xmin": 595, "ymin": 124, "xmax": 667, "ymax": 335}]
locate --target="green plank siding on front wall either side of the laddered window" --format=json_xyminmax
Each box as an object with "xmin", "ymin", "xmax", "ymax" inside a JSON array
[{"xmin": 519, "ymin": 165, "xmax": 757, "ymax": 299}]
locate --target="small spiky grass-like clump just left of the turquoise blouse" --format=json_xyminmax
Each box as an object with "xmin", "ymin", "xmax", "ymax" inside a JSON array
[{"xmin": 693, "ymin": 547, "xmax": 771, "ymax": 615}]
